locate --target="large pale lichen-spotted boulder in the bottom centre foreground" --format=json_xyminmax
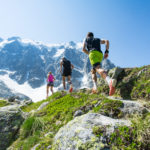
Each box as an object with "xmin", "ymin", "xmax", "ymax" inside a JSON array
[{"xmin": 54, "ymin": 113, "xmax": 130, "ymax": 150}]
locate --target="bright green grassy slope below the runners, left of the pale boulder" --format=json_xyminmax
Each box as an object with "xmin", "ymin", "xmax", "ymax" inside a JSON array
[{"xmin": 9, "ymin": 92, "xmax": 125, "ymax": 150}]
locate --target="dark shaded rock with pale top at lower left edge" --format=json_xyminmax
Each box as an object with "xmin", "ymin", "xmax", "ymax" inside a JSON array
[{"xmin": 0, "ymin": 105, "xmax": 24, "ymax": 150}]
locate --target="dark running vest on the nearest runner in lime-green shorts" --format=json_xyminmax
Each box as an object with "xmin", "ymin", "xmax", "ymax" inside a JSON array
[{"xmin": 85, "ymin": 37, "xmax": 102, "ymax": 53}]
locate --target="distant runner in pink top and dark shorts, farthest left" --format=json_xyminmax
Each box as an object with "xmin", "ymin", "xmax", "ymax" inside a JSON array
[{"xmin": 46, "ymin": 72, "xmax": 55, "ymax": 98}]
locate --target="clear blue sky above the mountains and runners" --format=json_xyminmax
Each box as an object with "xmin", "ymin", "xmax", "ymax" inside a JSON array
[{"xmin": 0, "ymin": 0, "xmax": 150, "ymax": 67}]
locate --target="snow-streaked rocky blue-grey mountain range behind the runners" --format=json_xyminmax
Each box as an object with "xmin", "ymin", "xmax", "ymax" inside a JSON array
[{"xmin": 0, "ymin": 37, "xmax": 114, "ymax": 101}]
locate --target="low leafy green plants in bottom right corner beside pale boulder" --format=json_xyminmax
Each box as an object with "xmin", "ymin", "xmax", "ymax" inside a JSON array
[{"xmin": 109, "ymin": 113, "xmax": 150, "ymax": 150}]
